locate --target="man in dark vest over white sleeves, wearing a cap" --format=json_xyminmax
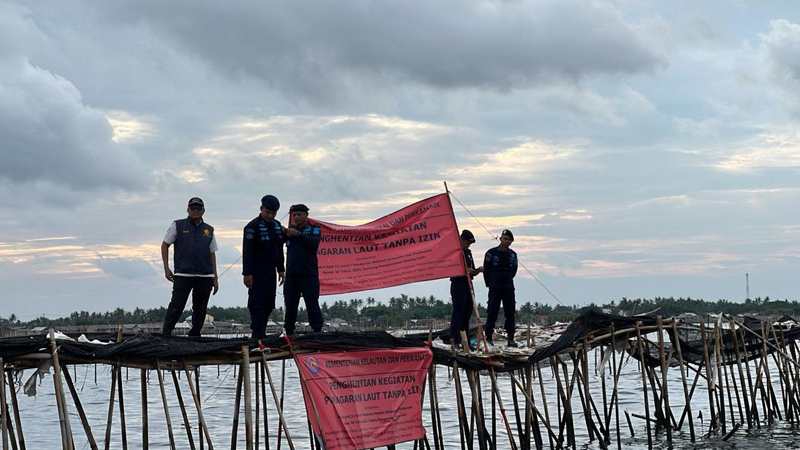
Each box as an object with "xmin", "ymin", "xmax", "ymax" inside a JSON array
[{"xmin": 161, "ymin": 197, "xmax": 219, "ymax": 336}]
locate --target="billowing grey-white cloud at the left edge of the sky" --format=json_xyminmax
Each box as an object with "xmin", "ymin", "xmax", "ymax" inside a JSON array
[{"xmin": 0, "ymin": 5, "xmax": 141, "ymax": 191}]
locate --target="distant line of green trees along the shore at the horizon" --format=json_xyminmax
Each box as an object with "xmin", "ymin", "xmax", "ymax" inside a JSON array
[{"xmin": 0, "ymin": 294, "xmax": 800, "ymax": 328}]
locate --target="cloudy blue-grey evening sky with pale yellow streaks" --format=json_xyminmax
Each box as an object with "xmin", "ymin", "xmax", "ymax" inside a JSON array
[{"xmin": 0, "ymin": 0, "xmax": 800, "ymax": 320}]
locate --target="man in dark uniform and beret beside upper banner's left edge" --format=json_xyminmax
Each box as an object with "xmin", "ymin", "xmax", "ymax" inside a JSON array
[{"xmin": 283, "ymin": 204, "xmax": 323, "ymax": 334}]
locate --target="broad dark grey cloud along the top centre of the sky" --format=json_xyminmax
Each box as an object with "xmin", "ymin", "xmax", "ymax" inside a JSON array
[{"xmin": 90, "ymin": 0, "xmax": 662, "ymax": 100}]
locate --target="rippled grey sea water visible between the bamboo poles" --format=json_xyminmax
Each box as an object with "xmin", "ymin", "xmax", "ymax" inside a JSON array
[{"xmin": 6, "ymin": 348, "xmax": 800, "ymax": 450}]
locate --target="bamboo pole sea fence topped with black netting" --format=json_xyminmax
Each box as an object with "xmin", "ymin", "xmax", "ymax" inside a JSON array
[{"xmin": 0, "ymin": 312, "xmax": 800, "ymax": 450}]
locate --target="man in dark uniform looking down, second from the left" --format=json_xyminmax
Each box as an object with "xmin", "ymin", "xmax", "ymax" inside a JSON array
[{"xmin": 242, "ymin": 195, "xmax": 286, "ymax": 339}]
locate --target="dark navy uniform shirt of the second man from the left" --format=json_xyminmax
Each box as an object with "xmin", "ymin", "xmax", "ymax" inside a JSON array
[{"xmin": 242, "ymin": 215, "xmax": 286, "ymax": 275}]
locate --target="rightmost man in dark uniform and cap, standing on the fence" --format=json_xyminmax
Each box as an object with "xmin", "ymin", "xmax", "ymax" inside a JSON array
[{"xmin": 483, "ymin": 230, "xmax": 518, "ymax": 347}]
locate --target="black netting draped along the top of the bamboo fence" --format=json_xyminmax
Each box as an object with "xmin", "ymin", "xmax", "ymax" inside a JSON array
[{"xmin": 6, "ymin": 312, "xmax": 800, "ymax": 372}]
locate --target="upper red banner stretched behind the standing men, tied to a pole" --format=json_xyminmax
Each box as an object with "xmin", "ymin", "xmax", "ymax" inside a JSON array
[{"xmin": 313, "ymin": 194, "xmax": 466, "ymax": 295}]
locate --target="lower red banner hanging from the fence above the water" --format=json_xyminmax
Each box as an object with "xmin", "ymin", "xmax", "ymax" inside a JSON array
[{"xmin": 297, "ymin": 348, "xmax": 433, "ymax": 450}]
